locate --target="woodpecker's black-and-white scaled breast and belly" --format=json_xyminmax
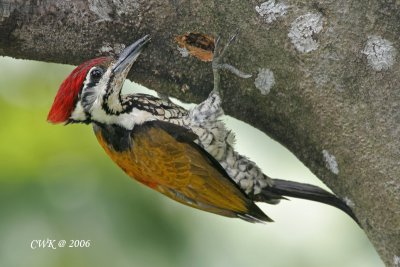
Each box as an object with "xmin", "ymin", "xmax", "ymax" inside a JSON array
[{"xmin": 123, "ymin": 92, "xmax": 271, "ymax": 197}]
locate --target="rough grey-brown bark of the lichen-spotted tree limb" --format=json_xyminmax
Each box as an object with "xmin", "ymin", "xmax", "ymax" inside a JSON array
[{"xmin": 0, "ymin": 0, "xmax": 400, "ymax": 267}]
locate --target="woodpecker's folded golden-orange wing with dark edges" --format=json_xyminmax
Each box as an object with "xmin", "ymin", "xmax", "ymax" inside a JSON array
[{"xmin": 95, "ymin": 121, "xmax": 271, "ymax": 222}]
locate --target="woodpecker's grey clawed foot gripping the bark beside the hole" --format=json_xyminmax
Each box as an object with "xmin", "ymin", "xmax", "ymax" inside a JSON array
[{"xmin": 212, "ymin": 32, "xmax": 251, "ymax": 94}]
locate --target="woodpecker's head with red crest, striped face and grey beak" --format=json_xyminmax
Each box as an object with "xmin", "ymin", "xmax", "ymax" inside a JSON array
[{"xmin": 47, "ymin": 35, "xmax": 150, "ymax": 123}]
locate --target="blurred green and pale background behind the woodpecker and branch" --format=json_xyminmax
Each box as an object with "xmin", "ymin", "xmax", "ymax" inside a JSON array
[{"xmin": 0, "ymin": 57, "xmax": 383, "ymax": 267}]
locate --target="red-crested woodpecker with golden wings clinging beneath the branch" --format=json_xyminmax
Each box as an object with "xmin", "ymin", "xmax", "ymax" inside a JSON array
[{"xmin": 47, "ymin": 35, "xmax": 357, "ymax": 225}]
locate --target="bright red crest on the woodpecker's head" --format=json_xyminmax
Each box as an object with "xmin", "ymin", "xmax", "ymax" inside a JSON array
[{"xmin": 47, "ymin": 57, "xmax": 110, "ymax": 123}]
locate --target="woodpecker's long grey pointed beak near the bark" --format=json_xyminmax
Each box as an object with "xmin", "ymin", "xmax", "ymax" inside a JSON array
[{"xmin": 111, "ymin": 35, "xmax": 150, "ymax": 76}]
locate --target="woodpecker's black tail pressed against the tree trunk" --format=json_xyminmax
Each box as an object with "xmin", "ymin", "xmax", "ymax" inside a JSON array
[{"xmin": 257, "ymin": 179, "xmax": 360, "ymax": 225}]
